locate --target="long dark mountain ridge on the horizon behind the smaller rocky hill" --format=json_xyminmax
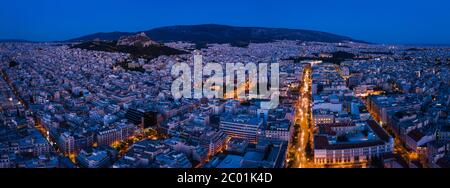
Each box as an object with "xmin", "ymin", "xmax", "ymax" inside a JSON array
[{"xmin": 69, "ymin": 24, "xmax": 366, "ymax": 46}]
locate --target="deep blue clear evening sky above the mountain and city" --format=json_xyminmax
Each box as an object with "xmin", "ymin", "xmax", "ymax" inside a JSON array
[{"xmin": 0, "ymin": 0, "xmax": 450, "ymax": 44}]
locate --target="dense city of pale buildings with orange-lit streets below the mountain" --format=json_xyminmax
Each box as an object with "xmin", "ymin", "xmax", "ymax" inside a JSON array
[{"xmin": 0, "ymin": 34, "xmax": 450, "ymax": 168}]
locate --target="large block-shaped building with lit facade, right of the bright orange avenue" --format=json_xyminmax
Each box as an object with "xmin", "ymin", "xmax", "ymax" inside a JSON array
[{"xmin": 314, "ymin": 120, "xmax": 394, "ymax": 164}]
